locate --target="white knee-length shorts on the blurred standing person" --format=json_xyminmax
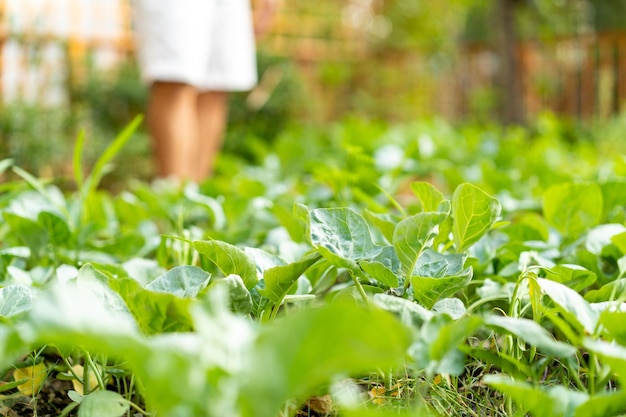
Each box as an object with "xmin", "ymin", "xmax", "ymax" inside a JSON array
[{"xmin": 134, "ymin": 0, "xmax": 257, "ymax": 91}]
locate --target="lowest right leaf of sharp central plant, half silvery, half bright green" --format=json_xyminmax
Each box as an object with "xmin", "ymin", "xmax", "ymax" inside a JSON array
[{"xmin": 411, "ymin": 249, "xmax": 473, "ymax": 308}]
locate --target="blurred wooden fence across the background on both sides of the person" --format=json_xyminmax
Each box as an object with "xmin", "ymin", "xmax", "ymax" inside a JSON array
[{"xmin": 0, "ymin": 0, "xmax": 626, "ymax": 120}]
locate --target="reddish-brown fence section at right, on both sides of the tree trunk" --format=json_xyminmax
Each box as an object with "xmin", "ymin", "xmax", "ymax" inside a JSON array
[{"xmin": 457, "ymin": 32, "xmax": 626, "ymax": 119}]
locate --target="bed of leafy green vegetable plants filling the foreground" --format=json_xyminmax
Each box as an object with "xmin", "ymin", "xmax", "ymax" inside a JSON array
[{"xmin": 0, "ymin": 117, "xmax": 626, "ymax": 417}]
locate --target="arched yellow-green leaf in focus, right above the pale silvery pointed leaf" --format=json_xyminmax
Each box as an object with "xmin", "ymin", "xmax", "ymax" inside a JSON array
[{"xmin": 193, "ymin": 240, "xmax": 258, "ymax": 289}]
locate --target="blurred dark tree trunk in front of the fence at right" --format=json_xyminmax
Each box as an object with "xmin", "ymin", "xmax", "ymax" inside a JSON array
[{"xmin": 495, "ymin": 0, "xmax": 525, "ymax": 124}]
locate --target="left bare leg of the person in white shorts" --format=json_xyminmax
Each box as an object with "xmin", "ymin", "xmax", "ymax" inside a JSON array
[{"xmin": 148, "ymin": 82, "xmax": 199, "ymax": 180}]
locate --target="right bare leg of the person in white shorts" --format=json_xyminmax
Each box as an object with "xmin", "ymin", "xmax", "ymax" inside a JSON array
[{"xmin": 194, "ymin": 91, "xmax": 228, "ymax": 181}]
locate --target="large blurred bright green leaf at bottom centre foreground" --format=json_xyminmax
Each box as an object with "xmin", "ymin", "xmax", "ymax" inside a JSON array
[{"xmin": 240, "ymin": 302, "xmax": 410, "ymax": 417}]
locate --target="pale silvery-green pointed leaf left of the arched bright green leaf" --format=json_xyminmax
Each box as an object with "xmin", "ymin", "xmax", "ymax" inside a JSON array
[{"xmin": 146, "ymin": 265, "xmax": 211, "ymax": 298}]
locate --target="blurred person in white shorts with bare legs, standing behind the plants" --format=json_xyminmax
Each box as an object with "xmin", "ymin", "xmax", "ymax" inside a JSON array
[{"xmin": 134, "ymin": 0, "xmax": 257, "ymax": 181}]
